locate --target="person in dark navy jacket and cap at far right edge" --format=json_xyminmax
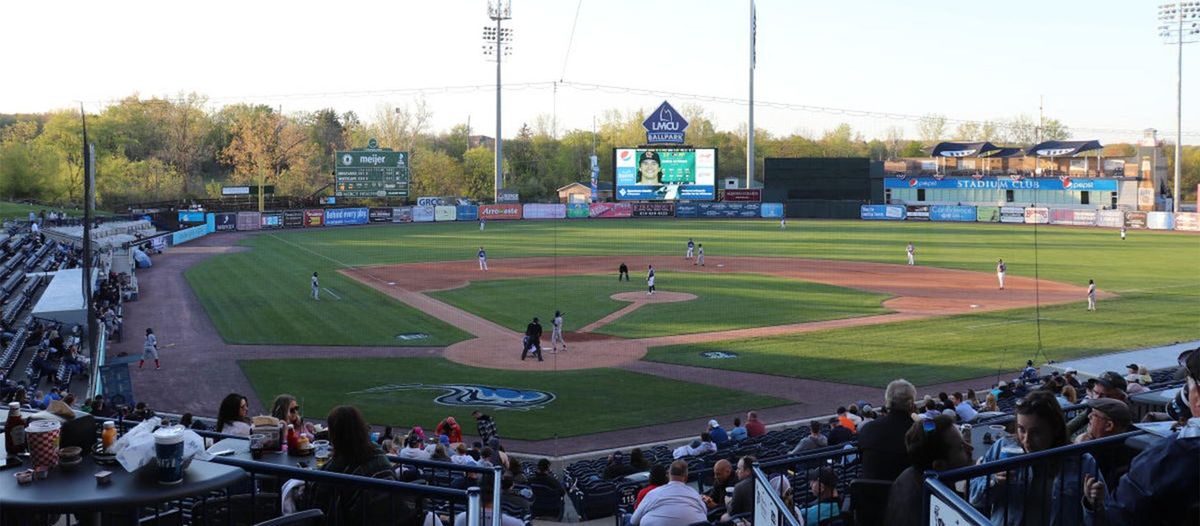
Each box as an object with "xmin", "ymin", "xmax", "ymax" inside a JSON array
[{"xmin": 1084, "ymin": 352, "xmax": 1200, "ymax": 526}]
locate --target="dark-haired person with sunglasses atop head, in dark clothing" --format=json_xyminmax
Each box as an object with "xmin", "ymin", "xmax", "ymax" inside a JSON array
[{"xmin": 887, "ymin": 416, "xmax": 971, "ymax": 526}]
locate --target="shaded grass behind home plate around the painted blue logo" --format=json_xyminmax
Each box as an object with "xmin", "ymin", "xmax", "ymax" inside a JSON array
[{"xmin": 239, "ymin": 358, "xmax": 788, "ymax": 440}]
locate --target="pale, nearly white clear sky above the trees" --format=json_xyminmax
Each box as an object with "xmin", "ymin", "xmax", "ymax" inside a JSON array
[{"xmin": 0, "ymin": 0, "xmax": 1200, "ymax": 144}]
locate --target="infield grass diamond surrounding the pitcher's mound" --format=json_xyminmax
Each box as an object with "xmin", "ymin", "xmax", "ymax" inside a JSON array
[{"xmin": 433, "ymin": 271, "xmax": 888, "ymax": 337}]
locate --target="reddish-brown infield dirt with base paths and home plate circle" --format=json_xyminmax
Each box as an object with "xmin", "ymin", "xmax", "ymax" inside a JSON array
[{"xmin": 341, "ymin": 256, "xmax": 1108, "ymax": 371}]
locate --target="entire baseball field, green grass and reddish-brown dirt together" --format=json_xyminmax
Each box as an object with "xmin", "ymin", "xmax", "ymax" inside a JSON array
[{"xmin": 162, "ymin": 220, "xmax": 1200, "ymax": 441}]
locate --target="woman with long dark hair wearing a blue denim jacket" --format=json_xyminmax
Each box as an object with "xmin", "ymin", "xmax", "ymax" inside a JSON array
[{"xmin": 971, "ymin": 390, "xmax": 1097, "ymax": 526}]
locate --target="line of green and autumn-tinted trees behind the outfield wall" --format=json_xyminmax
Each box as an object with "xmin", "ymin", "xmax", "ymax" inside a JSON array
[{"xmin": 0, "ymin": 94, "xmax": 1200, "ymax": 208}]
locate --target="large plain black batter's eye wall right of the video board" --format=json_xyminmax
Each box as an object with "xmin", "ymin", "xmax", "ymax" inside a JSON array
[{"xmin": 762, "ymin": 157, "xmax": 883, "ymax": 219}]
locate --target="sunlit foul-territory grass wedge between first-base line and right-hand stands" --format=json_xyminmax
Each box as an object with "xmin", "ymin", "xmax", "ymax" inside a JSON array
[{"xmin": 646, "ymin": 286, "xmax": 1200, "ymax": 388}]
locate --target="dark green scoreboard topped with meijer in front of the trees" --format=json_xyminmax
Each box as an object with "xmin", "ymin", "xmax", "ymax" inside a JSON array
[{"xmin": 334, "ymin": 139, "xmax": 410, "ymax": 197}]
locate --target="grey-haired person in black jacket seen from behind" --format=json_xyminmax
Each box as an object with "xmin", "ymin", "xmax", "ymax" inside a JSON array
[{"xmin": 858, "ymin": 379, "xmax": 917, "ymax": 480}]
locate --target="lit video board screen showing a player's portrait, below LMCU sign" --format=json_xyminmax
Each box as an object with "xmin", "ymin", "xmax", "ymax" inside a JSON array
[{"xmin": 612, "ymin": 148, "xmax": 716, "ymax": 201}]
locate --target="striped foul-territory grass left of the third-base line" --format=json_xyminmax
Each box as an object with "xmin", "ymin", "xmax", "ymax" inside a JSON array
[{"xmin": 184, "ymin": 235, "xmax": 469, "ymax": 346}]
